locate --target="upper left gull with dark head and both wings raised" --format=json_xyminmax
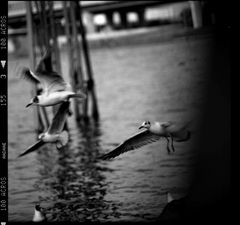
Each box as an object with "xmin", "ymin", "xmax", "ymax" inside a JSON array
[{"xmin": 21, "ymin": 49, "xmax": 86, "ymax": 107}]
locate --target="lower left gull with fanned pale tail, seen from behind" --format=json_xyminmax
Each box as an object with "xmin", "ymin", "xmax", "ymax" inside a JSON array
[{"xmin": 18, "ymin": 101, "xmax": 70, "ymax": 157}]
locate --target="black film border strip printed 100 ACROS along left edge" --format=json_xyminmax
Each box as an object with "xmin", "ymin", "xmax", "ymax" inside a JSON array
[{"xmin": 0, "ymin": 1, "xmax": 8, "ymax": 224}]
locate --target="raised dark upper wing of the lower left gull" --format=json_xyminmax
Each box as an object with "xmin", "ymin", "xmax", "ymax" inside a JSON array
[{"xmin": 47, "ymin": 101, "xmax": 70, "ymax": 134}]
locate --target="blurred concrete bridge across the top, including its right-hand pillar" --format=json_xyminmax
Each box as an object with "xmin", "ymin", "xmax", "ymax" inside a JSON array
[{"xmin": 8, "ymin": 1, "xmax": 202, "ymax": 52}]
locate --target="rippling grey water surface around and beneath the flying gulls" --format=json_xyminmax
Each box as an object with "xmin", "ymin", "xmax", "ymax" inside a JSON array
[{"xmin": 8, "ymin": 31, "xmax": 212, "ymax": 222}]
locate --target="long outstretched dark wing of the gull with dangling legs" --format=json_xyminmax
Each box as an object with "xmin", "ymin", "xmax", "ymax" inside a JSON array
[{"xmin": 101, "ymin": 130, "xmax": 160, "ymax": 160}]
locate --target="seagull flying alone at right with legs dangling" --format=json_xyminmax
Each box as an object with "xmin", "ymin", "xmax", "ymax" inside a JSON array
[{"xmin": 100, "ymin": 121, "xmax": 191, "ymax": 160}]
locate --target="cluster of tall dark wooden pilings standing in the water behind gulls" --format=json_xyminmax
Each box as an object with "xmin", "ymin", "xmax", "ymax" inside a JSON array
[{"xmin": 26, "ymin": 1, "xmax": 99, "ymax": 132}]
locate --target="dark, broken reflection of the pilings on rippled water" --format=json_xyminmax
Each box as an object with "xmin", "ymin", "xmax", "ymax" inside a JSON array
[{"xmin": 32, "ymin": 121, "xmax": 119, "ymax": 222}]
